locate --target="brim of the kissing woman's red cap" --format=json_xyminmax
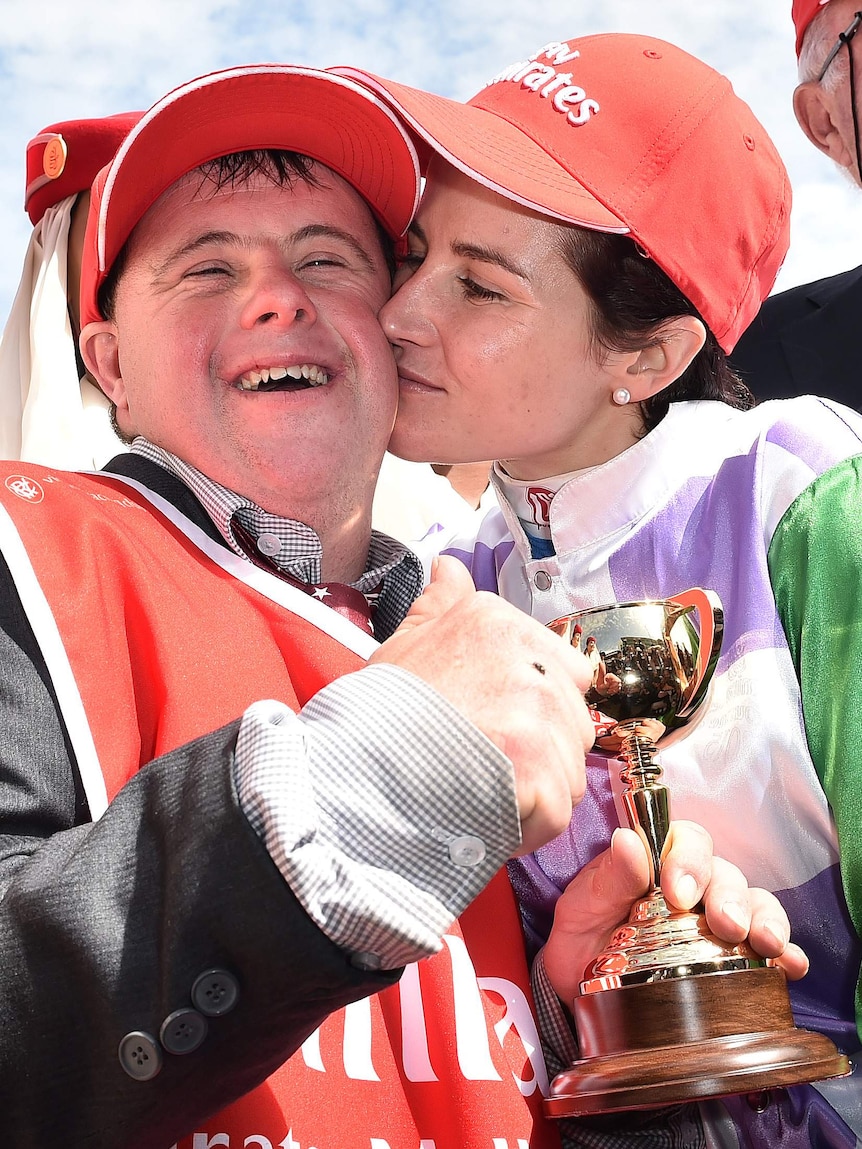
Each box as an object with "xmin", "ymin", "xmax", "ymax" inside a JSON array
[{"xmin": 330, "ymin": 68, "xmax": 630, "ymax": 234}]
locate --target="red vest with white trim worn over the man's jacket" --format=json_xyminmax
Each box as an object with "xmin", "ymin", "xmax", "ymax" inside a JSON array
[{"xmin": 0, "ymin": 463, "xmax": 559, "ymax": 1149}]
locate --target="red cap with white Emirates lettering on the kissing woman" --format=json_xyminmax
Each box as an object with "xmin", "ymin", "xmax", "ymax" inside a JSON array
[{"xmin": 336, "ymin": 33, "xmax": 791, "ymax": 352}]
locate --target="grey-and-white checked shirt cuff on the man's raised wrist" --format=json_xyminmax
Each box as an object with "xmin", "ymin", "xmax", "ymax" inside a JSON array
[{"xmin": 234, "ymin": 664, "xmax": 521, "ymax": 969}]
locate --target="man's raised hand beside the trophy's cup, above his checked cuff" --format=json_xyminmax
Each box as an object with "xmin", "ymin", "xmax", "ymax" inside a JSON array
[{"xmin": 369, "ymin": 556, "xmax": 595, "ymax": 853}]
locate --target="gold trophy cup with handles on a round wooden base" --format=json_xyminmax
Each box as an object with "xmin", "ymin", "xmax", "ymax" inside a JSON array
[{"xmin": 545, "ymin": 588, "xmax": 849, "ymax": 1117}]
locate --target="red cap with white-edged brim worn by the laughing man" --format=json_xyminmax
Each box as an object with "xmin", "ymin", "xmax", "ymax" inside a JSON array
[{"xmin": 80, "ymin": 64, "xmax": 420, "ymax": 326}]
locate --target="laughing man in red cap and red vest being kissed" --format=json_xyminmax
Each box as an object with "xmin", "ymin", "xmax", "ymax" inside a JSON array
[{"xmin": 0, "ymin": 65, "xmax": 804, "ymax": 1149}]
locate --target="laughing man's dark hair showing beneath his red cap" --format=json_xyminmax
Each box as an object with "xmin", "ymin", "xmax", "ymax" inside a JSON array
[{"xmin": 98, "ymin": 148, "xmax": 395, "ymax": 319}]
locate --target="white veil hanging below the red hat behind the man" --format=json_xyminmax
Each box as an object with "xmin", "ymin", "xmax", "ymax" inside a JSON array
[{"xmin": 0, "ymin": 195, "xmax": 124, "ymax": 470}]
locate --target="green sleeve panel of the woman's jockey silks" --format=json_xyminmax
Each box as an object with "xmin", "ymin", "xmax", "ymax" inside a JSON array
[{"xmin": 768, "ymin": 456, "xmax": 862, "ymax": 1033}]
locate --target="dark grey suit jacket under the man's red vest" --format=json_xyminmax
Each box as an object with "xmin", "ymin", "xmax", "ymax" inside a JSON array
[{"xmin": 0, "ymin": 456, "xmax": 397, "ymax": 1149}]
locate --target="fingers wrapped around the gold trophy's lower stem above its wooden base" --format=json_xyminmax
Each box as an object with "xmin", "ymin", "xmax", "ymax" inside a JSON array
[{"xmin": 544, "ymin": 822, "xmax": 808, "ymax": 1002}]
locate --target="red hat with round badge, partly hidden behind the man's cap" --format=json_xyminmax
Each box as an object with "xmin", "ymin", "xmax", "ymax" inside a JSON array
[{"xmin": 24, "ymin": 111, "xmax": 141, "ymax": 226}]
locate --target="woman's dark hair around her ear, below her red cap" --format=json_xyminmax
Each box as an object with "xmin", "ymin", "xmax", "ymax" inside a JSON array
[{"xmin": 561, "ymin": 228, "xmax": 754, "ymax": 431}]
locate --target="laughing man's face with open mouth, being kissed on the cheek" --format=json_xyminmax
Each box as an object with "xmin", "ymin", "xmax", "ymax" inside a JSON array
[{"xmin": 84, "ymin": 164, "xmax": 397, "ymax": 522}]
